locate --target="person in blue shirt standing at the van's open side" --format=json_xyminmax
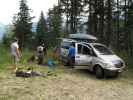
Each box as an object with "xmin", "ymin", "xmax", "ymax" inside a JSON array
[{"xmin": 68, "ymin": 43, "xmax": 75, "ymax": 67}]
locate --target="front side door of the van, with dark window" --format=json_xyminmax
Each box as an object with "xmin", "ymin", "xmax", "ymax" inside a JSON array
[{"xmin": 75, "ymin": 43, "xmax": 92, "ymax": 69}]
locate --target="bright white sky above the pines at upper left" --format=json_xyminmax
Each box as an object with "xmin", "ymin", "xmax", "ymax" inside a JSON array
[{"xmin": 0, "ymin": 0, "xmax": 58, "ymax": 24}]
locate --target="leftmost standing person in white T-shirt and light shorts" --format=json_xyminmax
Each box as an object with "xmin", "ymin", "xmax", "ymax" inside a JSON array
[{"xmin": 11, "ymin": 38, "xmax": 20, "ymax": 70}]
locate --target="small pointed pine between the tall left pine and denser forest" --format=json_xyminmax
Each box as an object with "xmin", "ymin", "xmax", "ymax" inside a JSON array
[{"xmin": 36, "ymin": 12, "xmax": 48, "ymax": 44}]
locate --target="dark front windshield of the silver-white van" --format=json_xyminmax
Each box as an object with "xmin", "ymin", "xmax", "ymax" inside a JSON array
[{"xmin": 93, "ymin": 45, "xmax": 113, "ymax": 55}]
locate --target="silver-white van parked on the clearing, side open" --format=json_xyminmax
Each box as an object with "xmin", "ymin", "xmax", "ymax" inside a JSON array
[{"xmin": 60, "ymin": 39, "xmax": 125, "ymax": 78}]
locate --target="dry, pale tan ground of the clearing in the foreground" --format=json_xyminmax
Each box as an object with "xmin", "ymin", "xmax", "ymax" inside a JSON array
[{"xmin": 0, "ymin": 66, "xmax": 133, "ymax": 100}]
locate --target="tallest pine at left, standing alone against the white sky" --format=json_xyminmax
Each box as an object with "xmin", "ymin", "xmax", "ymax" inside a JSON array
[{"xmin": 13, "ymin": 0, "xmax": 33, "ymax": 48}]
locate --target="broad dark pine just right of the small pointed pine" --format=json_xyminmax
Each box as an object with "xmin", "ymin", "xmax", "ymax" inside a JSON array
[{"xmin": 48, "ymin": 6, "xmax": 62, "ymax": 46}]
